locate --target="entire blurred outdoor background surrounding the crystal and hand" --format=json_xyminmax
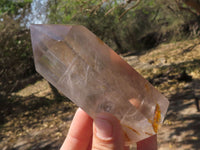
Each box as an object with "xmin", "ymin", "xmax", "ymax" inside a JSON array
[{"xmin": 0, "ymin": 0, "xmax": 200, "ymax": 150}]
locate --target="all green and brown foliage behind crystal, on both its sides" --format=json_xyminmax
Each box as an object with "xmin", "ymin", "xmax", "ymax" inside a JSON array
[{"xmin": 0, "ymin": 0, "xmax": 200, "ymax": 91}]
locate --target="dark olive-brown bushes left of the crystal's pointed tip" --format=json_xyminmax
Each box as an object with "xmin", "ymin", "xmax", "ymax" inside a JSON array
[{"xmin": 0, "ymin": 0, "xmax": 34, "ymax": 95}]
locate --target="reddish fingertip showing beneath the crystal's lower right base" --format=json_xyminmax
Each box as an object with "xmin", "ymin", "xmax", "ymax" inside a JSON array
[{"xmin": 137, "ymin": 135, "xmax": 157, "ymax": 150}]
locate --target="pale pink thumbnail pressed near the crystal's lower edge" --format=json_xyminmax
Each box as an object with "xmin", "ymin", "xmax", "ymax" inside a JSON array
[{"xmin": 94, "ymin": 117, "xmax": 113, "ymax": 140}]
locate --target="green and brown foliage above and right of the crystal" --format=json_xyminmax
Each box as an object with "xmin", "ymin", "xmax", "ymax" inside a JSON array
[{"xmin": 46, "ymin": 0, "xmax": 199, "ymax": 53}]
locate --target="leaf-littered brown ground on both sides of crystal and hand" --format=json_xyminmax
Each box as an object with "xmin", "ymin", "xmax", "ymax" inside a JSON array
[{"xmin": 0, "ymin": 39, "xmax": 200, "ymax": 150}]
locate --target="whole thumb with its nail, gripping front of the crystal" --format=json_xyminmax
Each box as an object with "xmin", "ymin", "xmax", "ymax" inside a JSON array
[{"xmin": 92, "ymin": 113, "xmax": 124, "ymax": 150}]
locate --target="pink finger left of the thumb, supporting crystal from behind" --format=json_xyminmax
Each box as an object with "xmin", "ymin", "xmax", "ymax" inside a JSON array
[{"xmin": 61, "ymin": 108, "xmax": 93, "ymax": 150}]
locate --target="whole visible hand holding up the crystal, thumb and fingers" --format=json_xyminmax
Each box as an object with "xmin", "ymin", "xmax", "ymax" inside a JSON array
[{"xmin": 61, "ymin": 108, "xmax": 157, "ymax": 150}]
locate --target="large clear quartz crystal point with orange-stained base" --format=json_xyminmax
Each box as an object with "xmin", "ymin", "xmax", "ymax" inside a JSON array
[{"xmin": 30, "ymin": 25, "xmax": 169, "ymax": 144}]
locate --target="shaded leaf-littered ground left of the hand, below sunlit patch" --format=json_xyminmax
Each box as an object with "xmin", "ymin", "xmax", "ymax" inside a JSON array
[{"xmin": 0, "ymin": 74, "xmax": 76, "ymax": 150}]
